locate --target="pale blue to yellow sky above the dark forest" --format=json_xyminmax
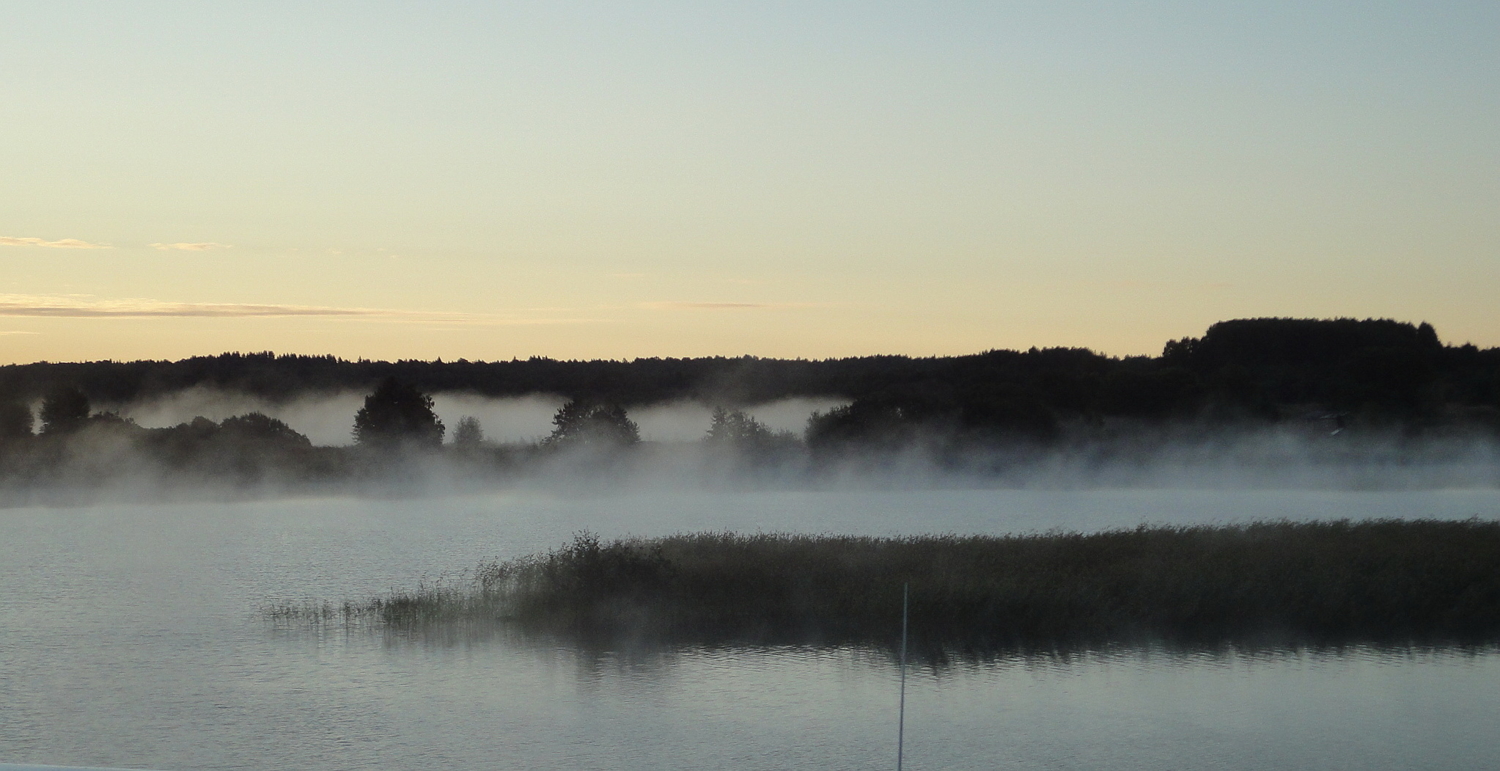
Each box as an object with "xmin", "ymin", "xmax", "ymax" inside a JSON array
[{"xmin": 0, "ymin": 0, "xmax": 1500, "ymax": 363}]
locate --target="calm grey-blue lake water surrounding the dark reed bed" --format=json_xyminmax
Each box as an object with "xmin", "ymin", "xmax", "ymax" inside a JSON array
[{"xmin": 0, "ymin": 491, "xmax": 1500, "ymax": 771}]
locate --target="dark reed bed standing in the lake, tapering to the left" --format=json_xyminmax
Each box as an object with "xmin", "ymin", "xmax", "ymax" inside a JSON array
[{"xmin": 273, "ymin": 519, "xmax": 1500, "ymax": 651}]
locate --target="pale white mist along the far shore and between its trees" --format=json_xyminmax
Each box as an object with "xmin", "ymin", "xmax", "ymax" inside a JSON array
[{"xmin": 0, "ymin": 389, "xmax": 1500, "ymax": 506}]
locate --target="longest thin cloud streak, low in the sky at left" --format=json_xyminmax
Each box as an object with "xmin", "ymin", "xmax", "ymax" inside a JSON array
[{"xmin": 0, "ymin": 294, "xmax": 597, "ymax": 326}]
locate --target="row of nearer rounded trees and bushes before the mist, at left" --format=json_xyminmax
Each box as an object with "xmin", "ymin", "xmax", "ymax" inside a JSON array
[{"xmin": 0, "ymin": 377, "xmax": 641, "ymax": 491}]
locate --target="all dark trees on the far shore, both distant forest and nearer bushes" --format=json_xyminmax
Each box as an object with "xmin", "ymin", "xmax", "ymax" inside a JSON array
[{"xmin": 0, "ymin": 318, "xmax": 1500, "ymax": 492}]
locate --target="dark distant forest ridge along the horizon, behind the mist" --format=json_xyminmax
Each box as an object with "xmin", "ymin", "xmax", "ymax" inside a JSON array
[{"xmin": 0, "ymin": 318, "xmax": 1500, "ymax": 444}]
